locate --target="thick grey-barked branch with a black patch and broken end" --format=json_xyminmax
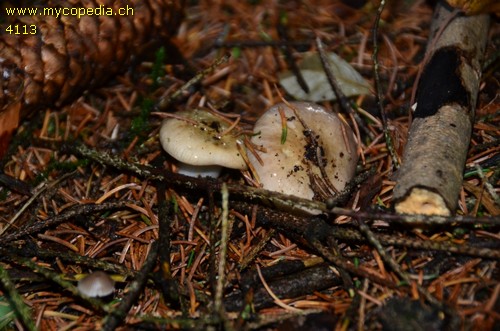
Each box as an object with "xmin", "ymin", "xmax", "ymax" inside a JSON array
[{"xmin": 393, "ymin": 2, "xmax": 489, "ymax": 215}]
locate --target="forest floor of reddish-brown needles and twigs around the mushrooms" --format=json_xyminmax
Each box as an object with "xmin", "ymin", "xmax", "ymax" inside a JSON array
[{"xmin": 0, "ymin": 0, "xmax": 500, "ymax": 330}]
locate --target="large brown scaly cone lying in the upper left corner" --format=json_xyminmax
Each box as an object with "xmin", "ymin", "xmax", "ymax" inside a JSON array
[{"xmin": 0, "ymin": 0, "xmax": 185, "ymax": 153}]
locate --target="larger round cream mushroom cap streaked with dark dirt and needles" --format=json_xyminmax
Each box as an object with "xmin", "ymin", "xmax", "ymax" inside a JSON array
[{"xmin": 248, "ymin": 102, "xmax": 358, "ymax": 210}]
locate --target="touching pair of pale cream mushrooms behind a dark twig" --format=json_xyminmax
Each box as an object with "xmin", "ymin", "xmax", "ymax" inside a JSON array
[{"xmin": 160, "ymin": 102, "xmax": 358, "ymax": 214}]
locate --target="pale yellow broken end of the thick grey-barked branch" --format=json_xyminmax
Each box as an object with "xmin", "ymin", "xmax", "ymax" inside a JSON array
[{"xmin": 394, "ymin": 188, "xmax": 451, "ymax": 216}]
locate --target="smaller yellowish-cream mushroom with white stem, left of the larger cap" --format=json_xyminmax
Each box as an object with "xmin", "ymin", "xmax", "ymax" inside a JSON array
[{"xmin": 160, "ymin": 109, "xmax": 247, "ymax": 177}]
